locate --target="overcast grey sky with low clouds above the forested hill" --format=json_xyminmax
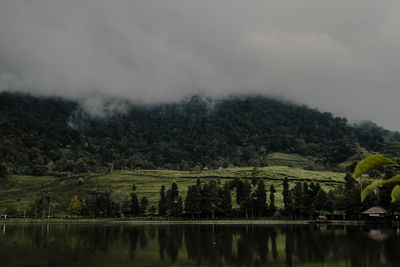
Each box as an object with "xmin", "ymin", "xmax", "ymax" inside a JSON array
[{"xmin": 0, "ymin": 0, "xmax": 400, "ymax": 130}]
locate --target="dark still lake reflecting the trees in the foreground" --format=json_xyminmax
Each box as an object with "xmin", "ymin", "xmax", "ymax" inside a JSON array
[{"xmin": 0, "ymin": 224, "xmax": 400, "ymax": 267}]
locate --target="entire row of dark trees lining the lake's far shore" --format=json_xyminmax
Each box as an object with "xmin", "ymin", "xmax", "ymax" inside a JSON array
[{"xmin": 24, "ymin": 170, "xmax": 399, "ymax": 219}]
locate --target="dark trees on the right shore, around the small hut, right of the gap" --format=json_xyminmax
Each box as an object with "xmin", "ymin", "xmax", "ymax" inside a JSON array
[{"xmin": 281, "ymin": 173, "xmax": 400, "ymax": 219}]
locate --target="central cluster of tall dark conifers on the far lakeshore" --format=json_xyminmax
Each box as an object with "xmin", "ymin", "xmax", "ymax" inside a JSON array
[{"xmin": 158, "ymin": 179, "xmax": 276, "ymax": 219}]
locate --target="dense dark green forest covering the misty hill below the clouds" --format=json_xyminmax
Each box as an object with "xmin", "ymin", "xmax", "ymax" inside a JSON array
[{"xmin": 0, "ymin": 93, "xmax": 400, "ymax": 175}]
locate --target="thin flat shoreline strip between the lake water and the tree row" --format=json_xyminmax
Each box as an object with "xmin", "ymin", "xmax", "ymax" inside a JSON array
[{"xmin": 0, "ymin": 218, "xmax": 367, "ymax": 225}]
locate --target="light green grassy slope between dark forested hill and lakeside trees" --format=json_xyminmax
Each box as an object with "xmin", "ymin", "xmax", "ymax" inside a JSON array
[{"xmin": 0, "ymin": 166, "xmax": 344, "ymax": 218}]
